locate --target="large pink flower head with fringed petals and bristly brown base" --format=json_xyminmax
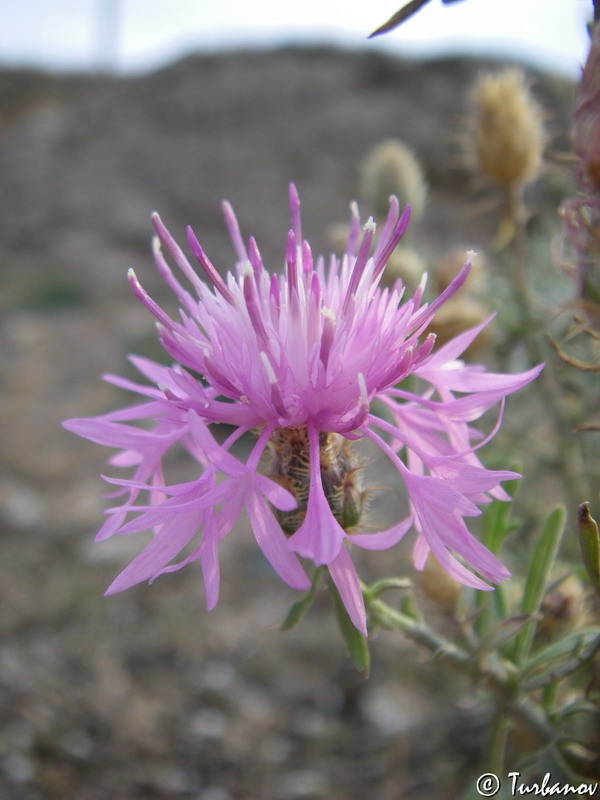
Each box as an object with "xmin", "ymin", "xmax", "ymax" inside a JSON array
[{"xmin": 64, "ymin": 185, "xmax": 541, "ymax": 633}]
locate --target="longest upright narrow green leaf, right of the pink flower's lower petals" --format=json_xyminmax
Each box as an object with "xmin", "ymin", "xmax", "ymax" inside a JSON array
[{"xmin": 514, "ymin": 506, "xmax": 567, "ymax": 664}]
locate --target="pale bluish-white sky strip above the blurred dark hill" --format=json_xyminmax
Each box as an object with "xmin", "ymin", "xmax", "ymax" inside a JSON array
[{"xmin": 0, "ymin": 0, "xmax": 592, "ymax": 77}]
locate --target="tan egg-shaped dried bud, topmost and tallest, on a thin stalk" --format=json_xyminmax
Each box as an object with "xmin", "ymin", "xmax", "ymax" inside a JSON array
[{"xmin": 470, "ymin": 68, "xmax": 545, "ymax": 189}]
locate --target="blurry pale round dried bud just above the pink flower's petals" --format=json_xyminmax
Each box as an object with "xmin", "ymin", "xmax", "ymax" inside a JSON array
[{"xmin": 362, "ymin": 139, "xmax": 427, "ymax": 220}]
